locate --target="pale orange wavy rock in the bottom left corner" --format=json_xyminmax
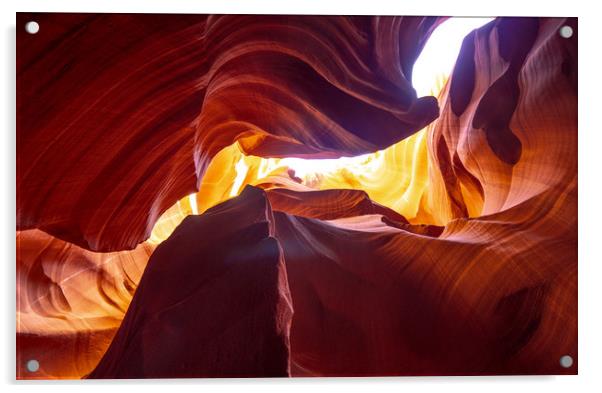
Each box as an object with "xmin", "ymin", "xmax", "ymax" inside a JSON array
[{"xmin": 17, "ymin": 230, "xmax": 155, "ymax": 378}]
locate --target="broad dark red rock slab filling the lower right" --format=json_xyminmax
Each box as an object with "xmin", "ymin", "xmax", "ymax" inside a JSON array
[{"xmin": 276, "ymin": 184, "xmax": 577, "ymax": 376}]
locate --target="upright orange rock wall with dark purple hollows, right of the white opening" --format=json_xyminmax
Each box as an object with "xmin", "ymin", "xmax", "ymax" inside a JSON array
[{"xmin": 429, "ymin": 18, "xmax": 577, "ymax": 224}]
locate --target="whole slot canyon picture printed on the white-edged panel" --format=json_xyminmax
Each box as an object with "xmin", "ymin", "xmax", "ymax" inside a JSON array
[{"xmin": 16, "ymin": 13, "xmax": 578, "ymax": 379}]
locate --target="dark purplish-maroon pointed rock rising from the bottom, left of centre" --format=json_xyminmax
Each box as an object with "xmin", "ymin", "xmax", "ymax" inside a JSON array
[{"xmin": 89, "ymin": 187, "xmax": 293, "ymax": 378}]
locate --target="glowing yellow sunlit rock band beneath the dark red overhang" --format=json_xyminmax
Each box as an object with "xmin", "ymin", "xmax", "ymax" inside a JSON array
[{"xmin": 148, "ymin": 75, "xmax": 458, "ymax": 244}]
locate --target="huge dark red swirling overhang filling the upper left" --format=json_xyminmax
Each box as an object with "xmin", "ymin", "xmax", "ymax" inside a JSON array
[{"xmin": 17, "ymin": 14, "xmax": 438, "ymax": 251}]
